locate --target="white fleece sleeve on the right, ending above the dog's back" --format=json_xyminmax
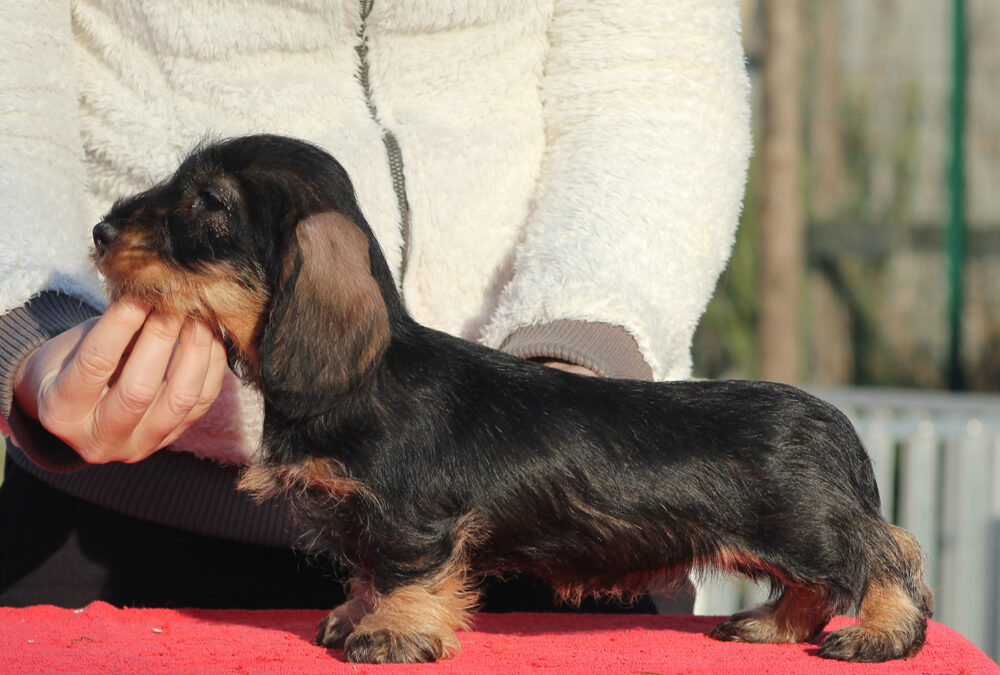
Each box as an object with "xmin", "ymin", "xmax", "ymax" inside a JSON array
[{"xmin": 483, "ymin": 0, "xmax": 751, "ymax": 379}]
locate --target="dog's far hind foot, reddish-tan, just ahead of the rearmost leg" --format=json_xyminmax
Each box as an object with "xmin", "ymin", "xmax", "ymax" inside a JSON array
[{"xmin": 709, "ymin": 584, "xmax": 836, "ymax": 642}]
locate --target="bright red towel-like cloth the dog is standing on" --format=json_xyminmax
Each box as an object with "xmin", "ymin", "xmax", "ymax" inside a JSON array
[{"xmin": 0, "ymin": 603, "xmax": 1000, "ymax": 675}]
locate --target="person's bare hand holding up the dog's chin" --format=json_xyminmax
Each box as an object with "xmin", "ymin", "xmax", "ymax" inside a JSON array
[{"xmin": 14, "ymin": 301, "xmax": 226, "ymax": 464}]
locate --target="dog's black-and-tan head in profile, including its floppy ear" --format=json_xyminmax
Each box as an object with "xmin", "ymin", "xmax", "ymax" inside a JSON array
[{"xmin": 94, "ymin": 135, "xmax": 402, "ymax": 412}]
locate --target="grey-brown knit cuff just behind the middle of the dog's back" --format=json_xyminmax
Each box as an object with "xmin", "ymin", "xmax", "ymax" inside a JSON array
[{"xmin": 500, "ymin": 320, "xmax": 653, "ymax": 380}]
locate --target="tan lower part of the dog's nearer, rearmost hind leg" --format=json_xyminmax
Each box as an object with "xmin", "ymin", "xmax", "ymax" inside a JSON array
[{"xmin": 819, "ymin": 525, "xmax": 934, "ymax": 662}]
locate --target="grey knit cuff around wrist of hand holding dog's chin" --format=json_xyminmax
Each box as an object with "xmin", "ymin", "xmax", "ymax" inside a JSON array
[{"xmin": 0, "ymin": 291, "xmax": 100, "ymax": 472}]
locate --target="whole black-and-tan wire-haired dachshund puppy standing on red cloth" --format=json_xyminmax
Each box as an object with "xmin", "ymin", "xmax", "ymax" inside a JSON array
[{"xmin": 94, "ymin": 135, "xmax": 933, "ymax": 662}]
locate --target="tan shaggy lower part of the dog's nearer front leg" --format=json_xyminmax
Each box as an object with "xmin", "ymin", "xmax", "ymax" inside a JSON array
[{"xmin": 340, "ymin": 573, "xmax": 475, "ymax": 663}]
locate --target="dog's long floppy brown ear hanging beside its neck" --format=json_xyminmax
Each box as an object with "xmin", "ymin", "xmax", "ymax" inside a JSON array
[{"xmin": 259, "ymin": 211, "xmax": 389, "ymax": 415}]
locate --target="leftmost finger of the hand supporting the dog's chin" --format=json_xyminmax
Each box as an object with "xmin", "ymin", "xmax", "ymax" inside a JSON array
[{"xmin": 39, "ymin": 302, "xmax": 149, "ymax": 427}]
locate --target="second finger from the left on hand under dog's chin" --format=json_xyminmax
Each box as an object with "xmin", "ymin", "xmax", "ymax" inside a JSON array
[{"xmin": 84, "ymin": 311, "xmax": 184, "ymax": 461}]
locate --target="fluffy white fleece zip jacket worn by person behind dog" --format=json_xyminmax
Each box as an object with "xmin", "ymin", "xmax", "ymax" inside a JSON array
[{"xmin": 0, "ymin": 0, "xmax": 751, "ymax": 461}]
